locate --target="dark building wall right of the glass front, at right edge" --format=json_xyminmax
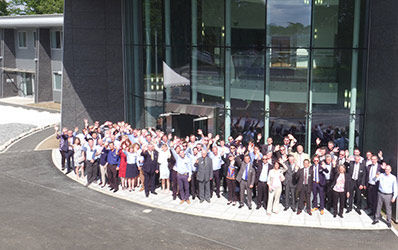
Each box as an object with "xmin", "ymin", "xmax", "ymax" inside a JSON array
[{"xmin": 365, "ymin": 0, "xmax": 398, "ymax": 220}]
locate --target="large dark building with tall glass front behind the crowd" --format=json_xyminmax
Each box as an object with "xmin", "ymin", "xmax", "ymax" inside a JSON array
[{"xmin": 62, "ymin": 0, "xmax": 398, "ymax": 219}]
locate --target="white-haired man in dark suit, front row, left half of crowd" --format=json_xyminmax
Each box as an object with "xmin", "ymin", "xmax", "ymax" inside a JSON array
[{"xmin": 141, "ymin": 144, "xmax": 159, "ymax": 197}]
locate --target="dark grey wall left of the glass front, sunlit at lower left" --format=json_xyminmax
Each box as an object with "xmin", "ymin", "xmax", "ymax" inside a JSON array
[{"xmin": 61, "ymin": 0, "xmax": 124, "ymax": 127}]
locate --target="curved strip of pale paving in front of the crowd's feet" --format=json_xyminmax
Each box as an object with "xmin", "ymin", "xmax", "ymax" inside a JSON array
[{"xmin": 52, "ymin": 150, "xmax": 387, "ymax": 230}]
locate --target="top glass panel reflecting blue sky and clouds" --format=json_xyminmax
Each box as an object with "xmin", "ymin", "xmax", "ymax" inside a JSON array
[{"xmin": 267, "ymin": 0, "xmax": 311, "ymax": 47}]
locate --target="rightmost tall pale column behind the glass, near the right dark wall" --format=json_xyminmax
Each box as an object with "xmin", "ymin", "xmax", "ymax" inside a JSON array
[{"xmin": 348, "ymin": 0, "xmax": 361, "ymax": 155}]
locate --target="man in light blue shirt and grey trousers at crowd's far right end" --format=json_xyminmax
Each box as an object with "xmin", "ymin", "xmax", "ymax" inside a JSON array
[{"xmin": 372, "ymin": 165, "xmax": 398, "ymax": 228}]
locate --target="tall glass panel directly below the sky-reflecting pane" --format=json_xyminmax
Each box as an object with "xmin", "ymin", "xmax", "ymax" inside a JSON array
[{"xmin": 269, "ymin": 49, "xmax": 309, "ymax": 145}]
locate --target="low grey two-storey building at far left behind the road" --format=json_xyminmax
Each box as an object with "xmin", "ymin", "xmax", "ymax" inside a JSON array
[{"xmin": 0, "ymin": 14, "xmax": 63, "ymax": 102}]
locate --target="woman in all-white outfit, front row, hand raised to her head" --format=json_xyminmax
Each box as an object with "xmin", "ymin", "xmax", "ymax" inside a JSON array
[{"xmin": 267, "ymin": 158, "xmax": 287, "ymax": 215}]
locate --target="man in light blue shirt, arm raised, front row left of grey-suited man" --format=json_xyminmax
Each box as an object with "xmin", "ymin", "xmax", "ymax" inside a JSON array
[{"xmin": 171, "ymin": 148, "xmax": 192, "ymax": 204}]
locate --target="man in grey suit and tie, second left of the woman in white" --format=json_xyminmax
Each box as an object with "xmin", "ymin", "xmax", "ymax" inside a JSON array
[{"xmin": 236, "ymin": 155, "xmax": 256, "ymax": 210}]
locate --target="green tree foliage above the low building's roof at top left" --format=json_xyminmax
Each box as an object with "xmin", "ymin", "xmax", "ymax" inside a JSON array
[{"xmin": 8, "ymin": 0, "xmax": 64, "ymax": 15}]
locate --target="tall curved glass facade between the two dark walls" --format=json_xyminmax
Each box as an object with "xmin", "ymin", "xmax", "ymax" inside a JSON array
[{"xmin": 123, "ymin": 0, "xmax": 367, "ymax": 152}]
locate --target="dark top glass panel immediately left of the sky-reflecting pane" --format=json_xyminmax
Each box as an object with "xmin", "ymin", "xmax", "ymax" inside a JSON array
[{"xmin": 231, "ymin": 0, "xmax": 265, "ymax": 48}]
